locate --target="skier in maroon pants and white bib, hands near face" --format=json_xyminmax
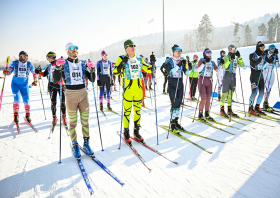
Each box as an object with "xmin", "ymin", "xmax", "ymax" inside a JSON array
[{"xmin": 197, "ymin": 48, "xmax": 218, "ymax": 120}]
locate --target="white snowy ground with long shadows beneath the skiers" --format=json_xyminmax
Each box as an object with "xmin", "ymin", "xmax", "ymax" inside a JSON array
[{"xmin": 0, "ymin": 65, "xmax": 280, "ymax": 198}]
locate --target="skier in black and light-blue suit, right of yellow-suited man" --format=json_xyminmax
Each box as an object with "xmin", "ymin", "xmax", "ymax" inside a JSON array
[{"xmin": 165, "ymin": 44, "xmax": 191, "ymax": 133}]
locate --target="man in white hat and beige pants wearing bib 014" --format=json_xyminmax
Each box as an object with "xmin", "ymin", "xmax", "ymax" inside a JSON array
[{"xmin": 53, "ymin": 42, "xmax": 95, "ymax": 158}]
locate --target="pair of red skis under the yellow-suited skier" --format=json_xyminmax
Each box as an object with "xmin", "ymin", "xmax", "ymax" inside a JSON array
[{"xmin": 117, "ymin": 131, "xmax": 178, "ymax": 172}]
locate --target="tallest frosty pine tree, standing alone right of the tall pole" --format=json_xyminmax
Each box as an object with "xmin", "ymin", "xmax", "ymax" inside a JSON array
[{"xmin": 196, "ymin": 14, "xmax": 213, "ymax": 50}]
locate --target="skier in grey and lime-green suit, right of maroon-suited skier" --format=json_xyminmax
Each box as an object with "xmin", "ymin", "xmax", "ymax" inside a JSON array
[{"xmin": 218, "ymin": 45, "xmax": 245, "ymax": 117}]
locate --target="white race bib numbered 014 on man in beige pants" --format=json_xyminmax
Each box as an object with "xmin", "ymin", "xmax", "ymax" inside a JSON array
[{"xmin": 68, "ymin": 61, "xmax": 84, "ymax": 85}]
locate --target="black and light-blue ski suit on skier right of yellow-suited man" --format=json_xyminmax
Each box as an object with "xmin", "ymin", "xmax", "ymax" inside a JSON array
[{"xmin": 165, "ymin": 57, "xmax": 191, "ymax": 120}]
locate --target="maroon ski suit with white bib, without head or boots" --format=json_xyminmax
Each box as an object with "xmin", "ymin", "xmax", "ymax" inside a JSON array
[{"xmin": 197, "ymin": 58, "xmax": 218, "ymax": 113}]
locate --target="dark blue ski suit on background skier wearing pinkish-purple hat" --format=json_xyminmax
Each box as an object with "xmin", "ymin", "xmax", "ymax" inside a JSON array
[{"xmin": 97, "ymin": 60, "xmax": 113, "ymax": 103}]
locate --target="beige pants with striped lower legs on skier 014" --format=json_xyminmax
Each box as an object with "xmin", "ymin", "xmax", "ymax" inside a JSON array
[{"xmin": 65, "ymin": 88, "xmax": 89, "ymax": 142}]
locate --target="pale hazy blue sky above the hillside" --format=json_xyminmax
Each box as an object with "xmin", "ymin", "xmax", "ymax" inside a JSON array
[{"xmin": 0, "ymin": 0, "xmax": 280, "ymax": 62}]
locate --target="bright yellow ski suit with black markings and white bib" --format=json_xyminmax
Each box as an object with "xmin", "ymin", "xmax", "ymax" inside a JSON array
[{"xmin": 114, "ymin": 55, "xmax": 152, "ymax": 128}]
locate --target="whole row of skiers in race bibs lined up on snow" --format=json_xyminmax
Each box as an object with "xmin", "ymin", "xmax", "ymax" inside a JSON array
[{"xmin": 3, "ymin": 39, "xmax": 279, "ymax": 158}]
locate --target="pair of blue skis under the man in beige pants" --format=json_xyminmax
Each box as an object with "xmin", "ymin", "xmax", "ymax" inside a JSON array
[{"xmin": 70, "ymin": 145, "xmax": 124, "ymax": 195}]
